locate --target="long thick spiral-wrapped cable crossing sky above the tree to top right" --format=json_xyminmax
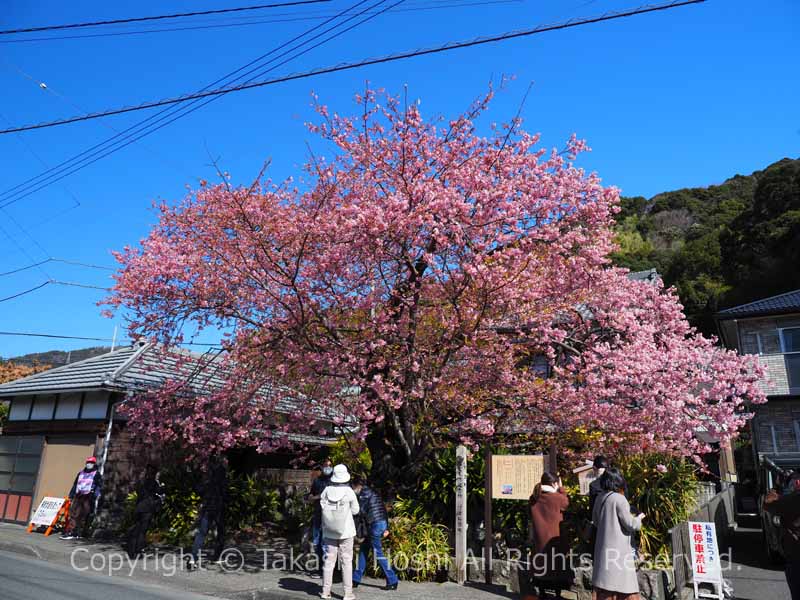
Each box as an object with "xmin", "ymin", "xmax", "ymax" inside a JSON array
[{"xmin": 0, "ymin": 0, "xmax": 706, "ymax": 134}]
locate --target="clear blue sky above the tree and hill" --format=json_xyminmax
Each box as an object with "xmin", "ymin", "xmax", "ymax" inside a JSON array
[{"xmin": 0, "ymin": 0, "xmax": 800, "ymax": 357}]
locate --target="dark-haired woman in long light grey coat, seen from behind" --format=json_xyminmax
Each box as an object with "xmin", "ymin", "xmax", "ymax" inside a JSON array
[{"xmin": 592, "ymin": 468, "xmax": 644, "ymax": 600}]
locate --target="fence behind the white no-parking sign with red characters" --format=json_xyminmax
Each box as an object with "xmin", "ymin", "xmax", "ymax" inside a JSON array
[{"xmin": 670, "ymin": 483, "xmax": 736, "ymax": 598}]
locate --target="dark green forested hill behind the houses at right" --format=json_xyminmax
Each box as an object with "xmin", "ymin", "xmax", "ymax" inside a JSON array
[{"xmin": 614, "ymin": 158, "xmax": 800, "ymax": 333}]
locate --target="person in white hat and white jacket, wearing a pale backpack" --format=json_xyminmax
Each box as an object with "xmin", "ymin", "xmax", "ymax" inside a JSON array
[{"xmin": 319, "ymin": 465, "xmax": 360, "ymax": 600}]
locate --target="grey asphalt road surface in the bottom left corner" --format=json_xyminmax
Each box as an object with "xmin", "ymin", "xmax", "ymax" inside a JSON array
[{"xmin": 0, "ymin": 551, "xmax": 219, "ymax": 600}]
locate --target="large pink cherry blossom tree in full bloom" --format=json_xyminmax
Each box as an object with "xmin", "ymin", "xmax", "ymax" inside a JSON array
[{"xmin": 108, "ymin": 90, "xmax": 763, "ymax": 482}]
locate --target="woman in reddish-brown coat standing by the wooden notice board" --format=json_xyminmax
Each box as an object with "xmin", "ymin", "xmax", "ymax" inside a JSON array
[{"xmin": 530, "ymin": 472, "xmax": 572, "ymax": 598}]
